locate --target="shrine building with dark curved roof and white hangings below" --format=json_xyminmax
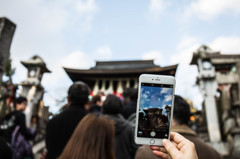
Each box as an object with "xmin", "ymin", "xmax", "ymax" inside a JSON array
[{"xmin": 64, "ymin": 60, "xmax": 178, "ymax": 95}]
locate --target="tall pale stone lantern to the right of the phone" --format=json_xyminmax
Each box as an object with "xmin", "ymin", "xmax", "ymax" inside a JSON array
[{"xmin": 190, "ymin": 45, "xmax": 229, "ymax": 155}]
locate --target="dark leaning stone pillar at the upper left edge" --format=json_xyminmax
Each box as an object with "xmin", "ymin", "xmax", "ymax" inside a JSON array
[{"xmin": 0, "ymin": 18, "xmax": 16, "ymax": 85}]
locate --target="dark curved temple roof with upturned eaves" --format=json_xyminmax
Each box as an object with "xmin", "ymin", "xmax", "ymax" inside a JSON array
[{"xmin": 64, "ymin": 60, "xmax": 178, "ymax": 81}]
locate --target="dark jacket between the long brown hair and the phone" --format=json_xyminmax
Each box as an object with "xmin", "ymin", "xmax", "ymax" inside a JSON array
[{"xmin": 108, "ymin": 114, "xmax": 138, "ymax": 159}]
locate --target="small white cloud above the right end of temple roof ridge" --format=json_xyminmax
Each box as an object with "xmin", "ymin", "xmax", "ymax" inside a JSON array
[{"xmin": 142, "ymin": 50, "xmax": 166, "ymax": 65}]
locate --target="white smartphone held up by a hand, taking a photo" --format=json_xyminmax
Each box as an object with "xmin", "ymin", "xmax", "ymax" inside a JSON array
[{"xmin": 135, "ymin": 74, "xmax": 176, "ymax": 146}]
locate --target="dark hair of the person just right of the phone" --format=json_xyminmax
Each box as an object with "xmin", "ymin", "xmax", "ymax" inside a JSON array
[{"xmin": 173, "ymin": 95, "xmax": 191, "ymax": 125}]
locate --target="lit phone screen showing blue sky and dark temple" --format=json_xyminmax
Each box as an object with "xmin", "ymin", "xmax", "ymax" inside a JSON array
[{"xmin": 137, "ymin": 83, "xmax": 173, "ymax": 138}]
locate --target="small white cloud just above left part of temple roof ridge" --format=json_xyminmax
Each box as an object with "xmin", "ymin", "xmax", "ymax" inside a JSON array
[{"xmin": 94, "ymin": 45, "xmax": 112, "ymax": 60}]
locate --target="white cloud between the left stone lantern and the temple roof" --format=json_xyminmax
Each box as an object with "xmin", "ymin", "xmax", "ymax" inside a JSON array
[{"xmin": 43, "ymin": 50, "xmax": 94, "ymax": 113}]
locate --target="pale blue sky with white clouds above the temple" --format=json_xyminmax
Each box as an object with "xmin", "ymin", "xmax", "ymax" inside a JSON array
[{"xmin": 0, "ymin": 0, "xmax": 240, "ymax": 111}]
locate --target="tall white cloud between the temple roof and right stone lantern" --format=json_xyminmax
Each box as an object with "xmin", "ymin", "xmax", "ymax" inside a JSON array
[{"xmin": 171, "ymin": 37, "xmax": 202, "ymax": 109}]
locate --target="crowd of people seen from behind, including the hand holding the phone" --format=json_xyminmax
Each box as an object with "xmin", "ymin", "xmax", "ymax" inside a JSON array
[{"xmin": 0, "ymin": 82, "xmax": 221, "ymax": 159}]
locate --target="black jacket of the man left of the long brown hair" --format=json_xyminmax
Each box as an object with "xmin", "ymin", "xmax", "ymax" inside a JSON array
[{"xmin": 46, "ymin": 104, "xmax": 86, "ymax": 159}]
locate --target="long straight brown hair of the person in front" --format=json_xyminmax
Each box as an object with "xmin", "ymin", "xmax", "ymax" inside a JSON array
[{"xmin": 59, "ymin": 113, "xmax": 115, "ymax": 159}]
